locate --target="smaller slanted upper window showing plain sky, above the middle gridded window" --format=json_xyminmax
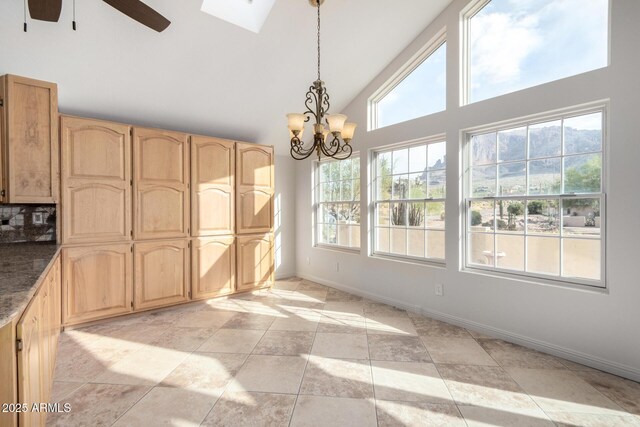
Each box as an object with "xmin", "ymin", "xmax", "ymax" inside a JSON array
[{"xmin": 370, "ymin": 34, "xmax": 447, "ymax": 129}]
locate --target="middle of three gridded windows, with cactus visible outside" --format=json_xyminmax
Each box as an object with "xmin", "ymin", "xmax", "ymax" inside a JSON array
[{"xmin": 373, "ymin": 138, "xmax": 447, "ymax": 262}]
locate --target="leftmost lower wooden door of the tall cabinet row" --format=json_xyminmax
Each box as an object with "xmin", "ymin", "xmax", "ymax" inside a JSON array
[{"xmin": 62, "ymin": 244, "xmax": 133, "ymax": 325}]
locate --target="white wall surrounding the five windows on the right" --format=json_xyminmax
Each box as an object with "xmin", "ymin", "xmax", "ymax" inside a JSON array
[{"xmin": 296, "ymin": 0, "xmax": 640, "ymax": 380}]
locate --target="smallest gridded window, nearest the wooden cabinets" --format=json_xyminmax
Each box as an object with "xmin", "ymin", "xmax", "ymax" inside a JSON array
[{"xmin": 315, "ymin": 155, "xmax": 360, "ymax": 248}]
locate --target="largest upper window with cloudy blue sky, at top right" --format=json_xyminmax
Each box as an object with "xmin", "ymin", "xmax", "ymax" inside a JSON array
[{"xmin": 465, "ymin": 0, "xmax": 609, "ymax": 102}]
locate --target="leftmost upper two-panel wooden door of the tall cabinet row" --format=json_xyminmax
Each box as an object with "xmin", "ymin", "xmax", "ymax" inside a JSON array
[{"xmin": 60, "ymin": 116, "xmax": 131, "ymax": 243}]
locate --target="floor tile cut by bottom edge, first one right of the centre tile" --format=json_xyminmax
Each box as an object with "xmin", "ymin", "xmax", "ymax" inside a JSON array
[{"xmin": 376, "ymin": 400, "xmax": 466, "ymax": 427}]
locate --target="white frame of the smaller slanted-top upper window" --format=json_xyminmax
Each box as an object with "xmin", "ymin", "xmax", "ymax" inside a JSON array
[{"xmin": 367, "ymin": 29, "xmax": 448, "ymax": 132}]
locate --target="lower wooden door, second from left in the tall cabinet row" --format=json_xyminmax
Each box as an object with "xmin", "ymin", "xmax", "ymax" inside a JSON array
[{"xmin": 134, "ymin": 240, "xmax": 189, "ymax": 310}]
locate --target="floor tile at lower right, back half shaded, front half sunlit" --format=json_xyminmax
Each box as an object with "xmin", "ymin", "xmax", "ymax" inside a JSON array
[{"xmin": 437, "ymin": 365, "xmax": 538, "ymax": 410}]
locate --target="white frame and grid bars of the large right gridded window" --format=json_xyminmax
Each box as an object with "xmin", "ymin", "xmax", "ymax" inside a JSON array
[{"xmin": 460, "ymin": 105, "xmax": 609, "ymax": 290}]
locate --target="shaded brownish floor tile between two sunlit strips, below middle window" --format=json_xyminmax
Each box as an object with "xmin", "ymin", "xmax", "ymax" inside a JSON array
[{"xmin": 367, "ymin": 335, "xmax": 431, "ymax": 362}]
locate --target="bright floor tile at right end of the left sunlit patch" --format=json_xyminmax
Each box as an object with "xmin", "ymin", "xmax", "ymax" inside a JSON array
[{"xmin": 160, "ymin": 353, "xmax": 247, "ymax": 397}]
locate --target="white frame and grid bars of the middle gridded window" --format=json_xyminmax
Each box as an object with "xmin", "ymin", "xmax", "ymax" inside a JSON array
[{"xmin": 369, "ymin": 133, "xmax": 447, "ymax": 267}]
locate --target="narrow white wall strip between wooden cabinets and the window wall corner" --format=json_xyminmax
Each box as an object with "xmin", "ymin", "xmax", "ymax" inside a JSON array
[{"xmin": 274, "ymin": 156, "xmax": 296, "ymax": 279}]
